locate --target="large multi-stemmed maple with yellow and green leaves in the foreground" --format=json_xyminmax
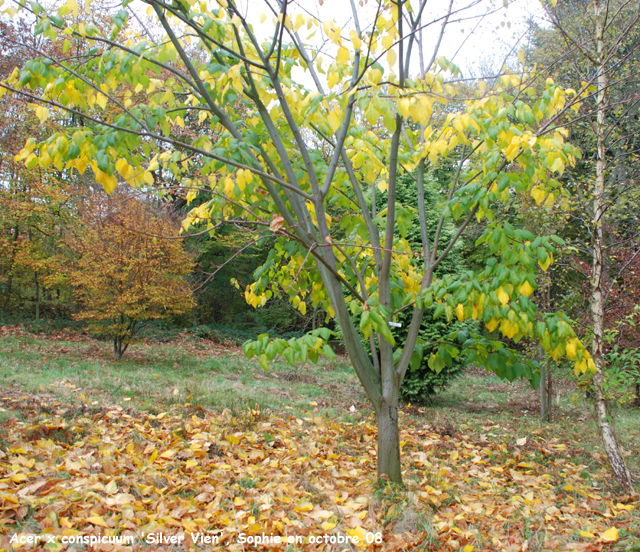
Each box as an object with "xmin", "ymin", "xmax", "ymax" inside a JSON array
[{"xmin": 1, "ymin": 0, "xmax": 592, "ymax": 482}]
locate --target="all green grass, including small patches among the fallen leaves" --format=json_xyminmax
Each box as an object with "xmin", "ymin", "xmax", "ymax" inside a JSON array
[{"xmin": 0, "ymin": 331, "xmax": 640, "ymax": 551}]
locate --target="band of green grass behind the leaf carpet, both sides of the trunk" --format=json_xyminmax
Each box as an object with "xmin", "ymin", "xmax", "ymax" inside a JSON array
[{"xmin": 0, "ymin": 331, "xmax": 640, "ymax": 477}]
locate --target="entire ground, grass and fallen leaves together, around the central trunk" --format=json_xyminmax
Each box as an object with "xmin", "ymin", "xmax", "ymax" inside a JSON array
[{"xmin": 0, "ymin": 327, "xmax": 640, "ymax": 552}]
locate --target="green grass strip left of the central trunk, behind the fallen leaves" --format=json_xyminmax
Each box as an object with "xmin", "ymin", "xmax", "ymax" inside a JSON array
[{"xmin": 0, "ymin": 333, "xmax": 365, "ymax": 415}]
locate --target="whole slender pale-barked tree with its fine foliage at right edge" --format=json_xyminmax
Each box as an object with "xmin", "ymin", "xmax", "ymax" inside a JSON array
[{"xmin": 541, "ymin": 0, "xmax": 640, "ymax": 490}]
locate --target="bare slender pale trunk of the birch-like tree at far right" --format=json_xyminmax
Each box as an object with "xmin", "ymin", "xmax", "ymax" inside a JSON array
[{"xmin": 591, "ymin": 0, "xmax": 633, "ymax": 491}]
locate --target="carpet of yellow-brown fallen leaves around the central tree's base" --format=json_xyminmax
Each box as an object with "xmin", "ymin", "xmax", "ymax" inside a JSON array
[{"xmin": 0, "ymin": 395, "xmax": 638, "ymax": 552}]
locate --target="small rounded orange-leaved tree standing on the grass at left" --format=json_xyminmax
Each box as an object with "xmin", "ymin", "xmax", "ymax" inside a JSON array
[{"xmin": 60, "ymin": 193, "xmax": 193, "ymax": 358}]
